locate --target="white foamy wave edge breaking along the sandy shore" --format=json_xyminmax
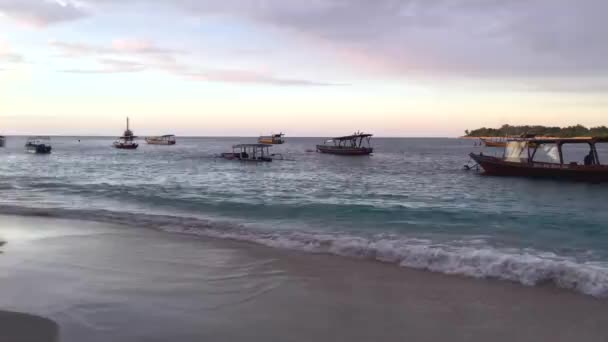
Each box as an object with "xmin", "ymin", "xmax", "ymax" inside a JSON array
[{"xmin": 0, "ymin": 206, "xmax": 608, "ymax": 298}]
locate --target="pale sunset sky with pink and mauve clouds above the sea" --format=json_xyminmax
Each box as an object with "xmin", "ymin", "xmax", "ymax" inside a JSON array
[{"xmin": 0, "ymin": 0, "xmax": 608, "ymax": 137}]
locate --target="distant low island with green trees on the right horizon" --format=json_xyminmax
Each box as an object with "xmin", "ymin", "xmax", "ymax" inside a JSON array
[{"xmin": 465, "ymin": 125, "xmax": 608, "ymax": 138}]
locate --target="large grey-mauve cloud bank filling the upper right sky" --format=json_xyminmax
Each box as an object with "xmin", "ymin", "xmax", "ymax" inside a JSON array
[{"xmin": 92, "ymin": 0, "xmax": 608, "ymax": 77}]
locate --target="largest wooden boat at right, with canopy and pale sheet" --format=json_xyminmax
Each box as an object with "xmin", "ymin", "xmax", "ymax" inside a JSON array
[{"xmin": 470, "ymin": 138, "xmax": 608, "ymax": 181}]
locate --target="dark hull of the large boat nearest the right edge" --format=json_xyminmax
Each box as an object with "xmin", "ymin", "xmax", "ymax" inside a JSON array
[{"xmin": 470, "ymin": 153, "xmax": 608, "ymax": 182}]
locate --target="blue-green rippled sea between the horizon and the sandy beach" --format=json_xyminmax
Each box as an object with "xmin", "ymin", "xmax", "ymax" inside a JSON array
[{"xmin": 0, "ymin": 137, "xmax": 608, "ymax": 297}]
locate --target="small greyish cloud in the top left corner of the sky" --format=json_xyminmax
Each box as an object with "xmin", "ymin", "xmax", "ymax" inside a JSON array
[{"xmin": 0, "ymin": 0, "xmax": 88, "ymax": 27}]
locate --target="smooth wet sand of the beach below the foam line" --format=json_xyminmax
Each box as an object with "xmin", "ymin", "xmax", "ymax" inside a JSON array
[{"xmin": 0, "ymin": 216, "xmax": 608, "ymax": 342}]
